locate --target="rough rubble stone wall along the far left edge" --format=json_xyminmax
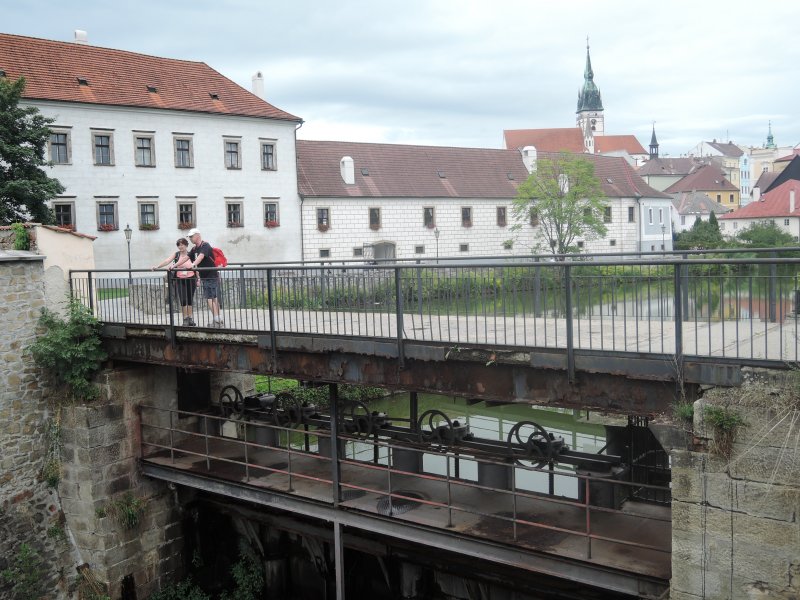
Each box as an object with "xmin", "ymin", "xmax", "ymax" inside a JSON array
[{"xmin": 0, "ymin": 251, "xmax": 78, "ymax": 599}]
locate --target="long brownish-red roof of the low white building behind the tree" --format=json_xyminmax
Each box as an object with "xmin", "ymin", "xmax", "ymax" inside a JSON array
[{"xmin": 297, "ymin": 140, "xmax": 670, "ymax": 198}]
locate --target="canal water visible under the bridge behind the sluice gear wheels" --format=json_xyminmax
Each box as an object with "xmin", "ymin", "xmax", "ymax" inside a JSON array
[{"xmin": 338, "ymin": 393, "xmax": 606, "ymax": 498}]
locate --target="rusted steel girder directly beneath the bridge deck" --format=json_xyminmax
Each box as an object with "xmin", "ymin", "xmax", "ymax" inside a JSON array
[{"xmin": 104, "ymin": 330, "xmax": 675, "ymax": 415}]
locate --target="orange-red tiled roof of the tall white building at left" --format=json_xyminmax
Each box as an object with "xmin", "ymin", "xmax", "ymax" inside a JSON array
[{"xmin": 0, "ymin": 34, "xmax": 301, "ymax": 121}]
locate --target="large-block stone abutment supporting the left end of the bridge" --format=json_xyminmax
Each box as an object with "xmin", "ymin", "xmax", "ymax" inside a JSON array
[{"xmin": 59, "ymin": 366, "xmax": 183, "ymax": 599}]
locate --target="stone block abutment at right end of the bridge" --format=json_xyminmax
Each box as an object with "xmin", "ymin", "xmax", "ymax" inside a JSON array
[{"xmin": 671, "ymin": 381, "xmax": 800, "ymax": 600}]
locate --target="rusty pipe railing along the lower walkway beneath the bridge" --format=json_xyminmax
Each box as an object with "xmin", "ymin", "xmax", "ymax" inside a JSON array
[{"xmin": 139, "ymin": 405, "xmax": 670, "ymax": 562}]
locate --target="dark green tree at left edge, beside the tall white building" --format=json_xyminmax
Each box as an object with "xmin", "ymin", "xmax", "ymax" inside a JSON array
[{"xmin": 0, "ymin": 77, "xmax": 64, "ymax": 225}]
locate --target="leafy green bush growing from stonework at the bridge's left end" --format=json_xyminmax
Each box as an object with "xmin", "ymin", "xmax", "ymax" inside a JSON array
[{"xmin": 29, "ymin": 299, "xmax": 107, "ymax": 400}]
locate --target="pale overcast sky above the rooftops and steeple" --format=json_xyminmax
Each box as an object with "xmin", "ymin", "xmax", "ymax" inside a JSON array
[{"xmin": 6, "ymin": 0, "xmax": 800, "ymax": 156}]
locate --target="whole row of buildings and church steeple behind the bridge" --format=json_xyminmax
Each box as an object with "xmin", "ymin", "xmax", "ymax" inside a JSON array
[{"xmin": 0, "ymin": 31, "xmax": 800, "ymax": 269}]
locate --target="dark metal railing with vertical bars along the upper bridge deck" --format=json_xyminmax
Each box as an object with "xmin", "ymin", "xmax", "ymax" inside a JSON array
[{"xmin": 71, "ymin": 254, "xmax": 800, "ymax": 372}]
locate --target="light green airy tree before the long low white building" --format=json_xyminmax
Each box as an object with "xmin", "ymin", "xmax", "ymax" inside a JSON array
[{"xmin": 513, "ymin": 153, "xmax": 606, "ymax": 254}]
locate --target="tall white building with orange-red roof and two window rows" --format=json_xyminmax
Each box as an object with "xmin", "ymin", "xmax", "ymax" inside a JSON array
[{"xmin": 0, "ymin": 34, "xmax": 302, "ymax": 269}]
